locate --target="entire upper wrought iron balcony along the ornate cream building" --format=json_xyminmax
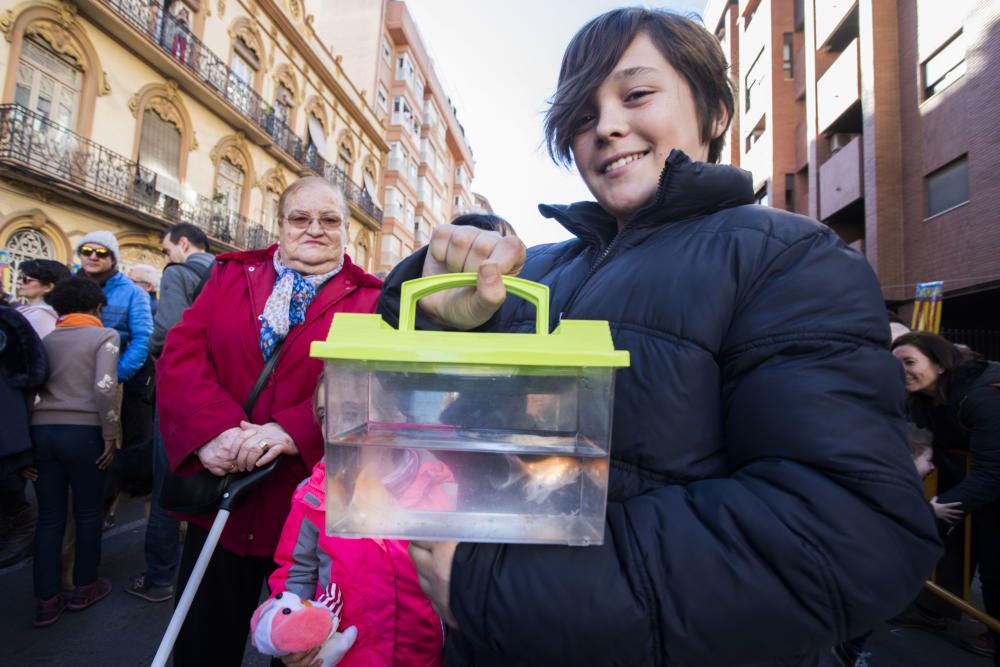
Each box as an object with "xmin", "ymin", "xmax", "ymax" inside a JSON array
[{"xmin": 102, "ymin": 0, "xmax": 382, "ymax": 228}]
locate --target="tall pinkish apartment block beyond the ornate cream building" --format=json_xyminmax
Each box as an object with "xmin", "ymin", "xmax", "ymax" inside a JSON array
[{"xmin": 312, "ymin": 0, "xmax": 475, "ymax": 269}]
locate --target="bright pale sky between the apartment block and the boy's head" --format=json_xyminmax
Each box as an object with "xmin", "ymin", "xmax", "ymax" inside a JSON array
[{"xmin": 406, "ymin": 0, "xmax": 705, "ymax": 246}]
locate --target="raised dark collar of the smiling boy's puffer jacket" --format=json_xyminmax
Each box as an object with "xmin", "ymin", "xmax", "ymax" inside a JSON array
[{"xmin": 538, "ymin": 149, "xmax": 754, "ymax": 245}]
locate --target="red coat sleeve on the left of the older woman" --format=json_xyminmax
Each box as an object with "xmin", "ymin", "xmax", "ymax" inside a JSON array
[{"xmin": 156, "ymin": 268, "xmax": 246, "ymax": 474}]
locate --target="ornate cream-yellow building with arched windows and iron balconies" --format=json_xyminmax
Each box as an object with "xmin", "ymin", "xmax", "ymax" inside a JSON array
[{"xmin": 0, "ymin": 0, "xmax": 389, "ymax": 290}]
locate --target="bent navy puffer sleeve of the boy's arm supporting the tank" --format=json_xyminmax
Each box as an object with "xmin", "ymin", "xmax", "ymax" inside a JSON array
[{"xmin": 450, "ymin": 229, "xmax": 940, "ymax": 665}]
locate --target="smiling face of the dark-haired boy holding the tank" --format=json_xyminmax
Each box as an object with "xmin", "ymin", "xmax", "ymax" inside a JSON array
[{"xmin": 571, "ymin": 33, "xmax": 725, "ymax": 228}]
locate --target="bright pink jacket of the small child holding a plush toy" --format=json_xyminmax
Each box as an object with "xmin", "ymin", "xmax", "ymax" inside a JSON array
[{"xmin": 269, "ymin": 461, "xmax": 444, "ymax": 667}]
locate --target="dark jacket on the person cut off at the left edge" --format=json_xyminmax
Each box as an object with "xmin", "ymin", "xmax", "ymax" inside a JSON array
[{"xmin": 0, "ymin": 306, "xmax": 49, "ymax": 474}]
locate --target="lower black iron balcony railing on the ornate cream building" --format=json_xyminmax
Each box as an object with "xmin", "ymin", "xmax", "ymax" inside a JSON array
[{"xmin": 0, "ymin": 104, "xmax": 275, "ymax": 249}]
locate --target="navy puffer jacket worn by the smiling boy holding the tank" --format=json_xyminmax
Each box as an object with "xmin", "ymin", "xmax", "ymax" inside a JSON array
[{"xmin": 381, "ymin": 151, "xmax": 940, "ymax": 666}]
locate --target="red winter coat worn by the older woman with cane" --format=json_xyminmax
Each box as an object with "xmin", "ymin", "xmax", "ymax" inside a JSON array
[{"xmin": 156, "ymin": 246, "xmax": 381, "ymax": 557}]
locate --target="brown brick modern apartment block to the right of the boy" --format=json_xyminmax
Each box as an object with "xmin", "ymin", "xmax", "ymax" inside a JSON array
[{"xmin": 704, "ymin": 0, "xmax": 1000, "ymax": 354}]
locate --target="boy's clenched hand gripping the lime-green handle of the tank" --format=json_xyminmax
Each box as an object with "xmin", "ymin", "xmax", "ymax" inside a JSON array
[{"xmin": 419, "ymin": 225, "xmax": 526, "ymax": 330}]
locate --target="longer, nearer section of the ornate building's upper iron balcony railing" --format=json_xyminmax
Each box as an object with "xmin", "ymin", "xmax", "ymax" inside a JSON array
[{"xmin": 104, "ymin": 0, "xmax": 304, "ymax": 163}]
